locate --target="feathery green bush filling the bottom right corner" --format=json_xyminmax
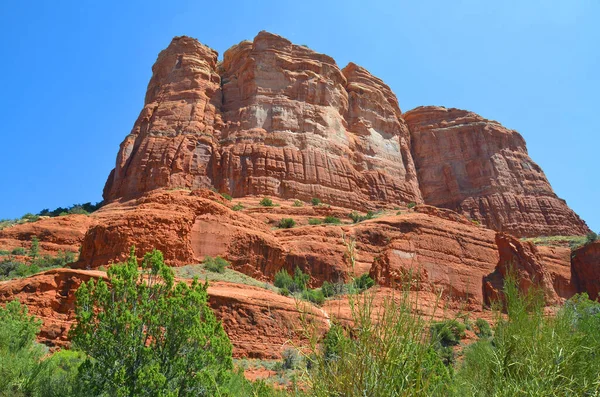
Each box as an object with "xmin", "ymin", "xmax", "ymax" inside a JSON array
[{"xmin": 457, "ymin": 275, "xmax": 600, "ymax": 397}]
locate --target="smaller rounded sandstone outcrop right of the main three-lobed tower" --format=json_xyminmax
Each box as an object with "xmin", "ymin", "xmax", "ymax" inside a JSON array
[{"xmin": 403, "ymin": 106, "xmax": 589, "ymax": 237}]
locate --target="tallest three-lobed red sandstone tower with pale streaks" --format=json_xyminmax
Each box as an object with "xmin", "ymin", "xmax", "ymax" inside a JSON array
[{"xmin": 104, "ymin": 32, "xmax": 422, "ymax": 208}]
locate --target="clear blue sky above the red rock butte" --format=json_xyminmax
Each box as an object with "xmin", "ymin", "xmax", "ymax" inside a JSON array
[{"xmin": 0, "ymin": 0, "xmax": 600, "ymax": 231}]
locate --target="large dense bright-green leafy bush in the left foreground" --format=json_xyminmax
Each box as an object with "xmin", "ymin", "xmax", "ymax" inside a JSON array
[{"xmin": 70, "ymin": 248, "xmax": 233, "ymax": 396}]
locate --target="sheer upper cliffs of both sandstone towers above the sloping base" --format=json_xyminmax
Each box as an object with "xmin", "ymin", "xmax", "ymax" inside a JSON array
[{"xmin": 104, "ymin": 32, "xmax": 588, "ymax": 236}]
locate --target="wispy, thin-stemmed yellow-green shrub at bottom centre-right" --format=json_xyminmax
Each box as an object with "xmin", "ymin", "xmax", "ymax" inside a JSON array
[{"xmin": 306, "ymin": 292, "xmax": 453, "ymax": 397}]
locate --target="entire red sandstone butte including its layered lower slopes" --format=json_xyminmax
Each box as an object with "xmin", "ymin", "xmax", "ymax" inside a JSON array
[{"xmin": 0, "ymin": 32, "xmax": 600, "ymax": 358}]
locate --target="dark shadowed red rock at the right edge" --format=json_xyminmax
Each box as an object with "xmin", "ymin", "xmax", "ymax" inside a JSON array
[{"xmin": 571, "ymin": 241, "xmax": 600, "ymax": 300}]
